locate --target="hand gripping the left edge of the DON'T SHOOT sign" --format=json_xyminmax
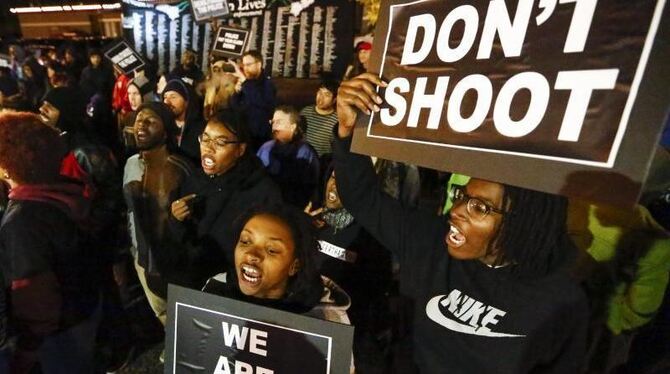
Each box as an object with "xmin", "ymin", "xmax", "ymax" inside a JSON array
[{"xmin": 337, "ymin": 73, "xmax": 387, "ymax": 138}]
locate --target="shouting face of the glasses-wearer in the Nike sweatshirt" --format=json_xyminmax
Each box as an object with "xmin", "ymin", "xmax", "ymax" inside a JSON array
[{"xmin": 445, "ymin": 179, "xmax": 504, "ymax": 263}]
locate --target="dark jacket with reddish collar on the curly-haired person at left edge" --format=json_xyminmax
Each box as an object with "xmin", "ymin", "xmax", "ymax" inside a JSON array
[{"xmin": 0, "ymin": 183, "xmax": 100, "ymax": 360}]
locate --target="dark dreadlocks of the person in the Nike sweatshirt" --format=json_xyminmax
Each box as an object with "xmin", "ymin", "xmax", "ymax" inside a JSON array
[{"xmin": 494, "ymin": 185, "xmax": 574, "ymax": 278}]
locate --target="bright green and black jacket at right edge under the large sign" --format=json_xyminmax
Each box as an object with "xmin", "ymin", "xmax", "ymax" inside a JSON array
[{"xmin": 568, "ymin": 200, "xmax": 670, "ymax": 334}]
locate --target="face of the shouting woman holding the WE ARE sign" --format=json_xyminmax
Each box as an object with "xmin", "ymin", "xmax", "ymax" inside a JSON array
[{"xmin": 235, "ymin": 214, "xmax": 299, "ymax": 299}]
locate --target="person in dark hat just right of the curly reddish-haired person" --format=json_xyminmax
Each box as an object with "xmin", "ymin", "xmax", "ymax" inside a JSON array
[{"xmin": 40, "ymin": 87, "xmax": 130, "ymax": 372}]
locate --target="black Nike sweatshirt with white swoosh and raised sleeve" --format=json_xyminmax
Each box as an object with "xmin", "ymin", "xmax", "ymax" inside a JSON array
[{"xmin": 334, "ymin": 136, "xmax": 588, "ymax": 373}]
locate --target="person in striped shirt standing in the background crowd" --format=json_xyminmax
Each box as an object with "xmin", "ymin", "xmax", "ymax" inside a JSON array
[{"xmin": 300, "ymin": 81, "xmax": 339, "ymax": 158}]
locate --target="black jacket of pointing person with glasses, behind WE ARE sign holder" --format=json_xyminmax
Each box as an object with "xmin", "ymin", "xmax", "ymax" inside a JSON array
[{"xmin": 170, "ymin": 155, "xmax": 281, "ymax": 289}]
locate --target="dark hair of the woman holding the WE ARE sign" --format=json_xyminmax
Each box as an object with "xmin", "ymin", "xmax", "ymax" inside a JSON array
[{"xmin": 231, "ymin": 203, "xmax": 323, "ymax": 309}]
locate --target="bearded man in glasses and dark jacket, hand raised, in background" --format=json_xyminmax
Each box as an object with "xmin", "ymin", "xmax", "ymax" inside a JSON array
[{"xmin": 230, "ymin": 51, "xmax": 277, "ymax": 152}]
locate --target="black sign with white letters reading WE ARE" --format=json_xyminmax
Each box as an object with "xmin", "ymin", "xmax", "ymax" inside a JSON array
[{"xmin": 164, "ymin": 285, "xmax": 354, "ymax": 374}]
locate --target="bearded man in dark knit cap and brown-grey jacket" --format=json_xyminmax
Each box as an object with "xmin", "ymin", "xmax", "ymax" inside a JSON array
[{"xmin": 123, "ymin": 102, "xmax": 191, "ymax": 325}]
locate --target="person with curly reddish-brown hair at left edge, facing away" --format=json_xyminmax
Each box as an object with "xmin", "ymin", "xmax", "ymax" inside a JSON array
[{"xmin": 0, "ymin": 113, "xmax": 100, "ymax": 374}]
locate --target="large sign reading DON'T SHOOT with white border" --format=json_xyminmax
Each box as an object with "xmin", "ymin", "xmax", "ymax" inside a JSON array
[{"xmin": 353, "ymin": 0, "xmax": 670, "ymax": 205}]
